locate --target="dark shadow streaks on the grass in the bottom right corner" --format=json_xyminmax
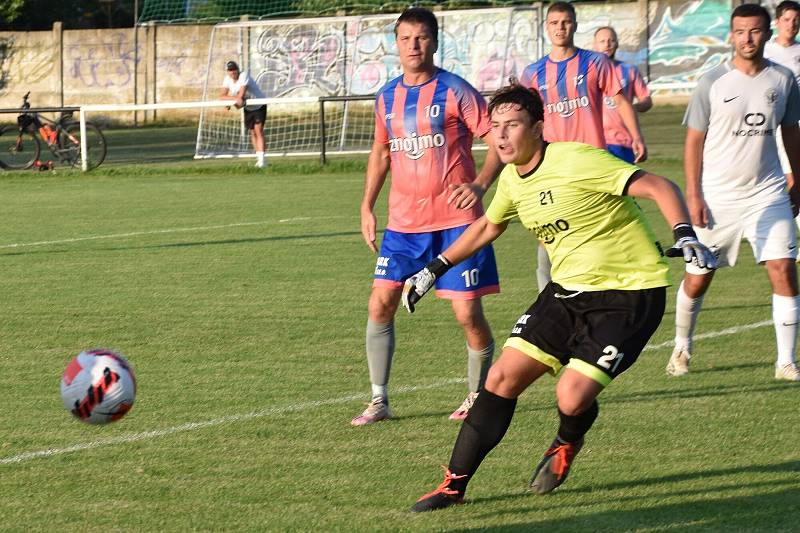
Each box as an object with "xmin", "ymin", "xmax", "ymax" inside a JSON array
[{"xmin": 445, "ymin": 461, "xmax": 800, "ymax": 532}]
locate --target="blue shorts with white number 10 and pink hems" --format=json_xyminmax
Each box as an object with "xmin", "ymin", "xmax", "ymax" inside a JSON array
[{"xmin": 372, "ymin": 225, "xmax": 500, "ymax": 300}]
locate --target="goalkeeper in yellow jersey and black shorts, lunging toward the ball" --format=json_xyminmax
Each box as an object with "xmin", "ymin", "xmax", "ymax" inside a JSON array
[{"xmin": 403, "ymin": 85, "xmax": 716, "ymax": 512}]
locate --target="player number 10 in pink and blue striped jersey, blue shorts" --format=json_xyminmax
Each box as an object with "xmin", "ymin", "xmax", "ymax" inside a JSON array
[{"xmin": 351, "ymin": 8, "xmax": 501, "ymax": 426}]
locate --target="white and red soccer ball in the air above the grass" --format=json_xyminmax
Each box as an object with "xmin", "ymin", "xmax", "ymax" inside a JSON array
[{"xmin": 61, "ymin": 348, "xmax": 136, "ymax": 424}]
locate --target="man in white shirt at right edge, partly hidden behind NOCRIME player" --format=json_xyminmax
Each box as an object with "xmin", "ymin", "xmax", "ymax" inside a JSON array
[{"xmin": 764, "ymin": 0, "xmax": 800, "ymax": 208}]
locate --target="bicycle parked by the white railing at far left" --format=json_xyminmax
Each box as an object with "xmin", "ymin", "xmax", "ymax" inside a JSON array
[{"xmin": 0, "ymin": 92, "xmax": 106, "ymax": 170}]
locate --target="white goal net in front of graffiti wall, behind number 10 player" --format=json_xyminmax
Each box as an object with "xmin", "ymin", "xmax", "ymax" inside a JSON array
[{"xmin": 197, "ymin": 8, "xmax": 541, "ymax": 158}]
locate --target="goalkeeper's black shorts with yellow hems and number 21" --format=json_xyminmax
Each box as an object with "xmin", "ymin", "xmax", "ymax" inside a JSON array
[{"xmin": 505, "ymin": 283, "xmax": 667, "ymax": 386}]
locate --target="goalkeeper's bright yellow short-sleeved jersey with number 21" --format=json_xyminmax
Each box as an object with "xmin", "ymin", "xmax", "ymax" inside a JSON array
[{"xmin": 486, "ymin": 142, "xmax": 670, "ymax": 291}]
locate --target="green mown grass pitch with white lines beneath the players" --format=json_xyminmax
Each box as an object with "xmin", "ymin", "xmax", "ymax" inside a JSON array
[{"xmin": 0, "ymin": 107, "xmax": 800, "ymax": 532}]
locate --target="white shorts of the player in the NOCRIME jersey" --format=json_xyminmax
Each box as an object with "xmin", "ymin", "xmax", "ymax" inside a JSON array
[{"xmin": 686, "ymin": 196, "xmax": 797, "ymax": 275}]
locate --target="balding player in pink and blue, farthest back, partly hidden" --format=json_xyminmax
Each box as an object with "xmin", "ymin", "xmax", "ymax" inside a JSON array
[{"xmin": 594, "ymin": 26, "xmax": 653, "ymax": 163}]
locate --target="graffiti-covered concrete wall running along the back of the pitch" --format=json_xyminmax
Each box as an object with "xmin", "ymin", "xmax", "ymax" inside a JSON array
[{"xmin": 0, "ymin": 0, "xmax": 731, "ymax": 117}]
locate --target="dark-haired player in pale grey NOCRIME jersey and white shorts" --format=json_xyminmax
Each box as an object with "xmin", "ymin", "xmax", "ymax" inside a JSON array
[{"xmin": 667, "ymin": 4, "xmax": 800, "ymax": 382}]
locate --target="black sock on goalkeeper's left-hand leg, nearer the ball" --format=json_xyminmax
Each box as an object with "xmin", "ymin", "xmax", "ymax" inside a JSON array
[{"xmin": 449, "ymin": 389, "xmax": 517, "ymax": 494}]
